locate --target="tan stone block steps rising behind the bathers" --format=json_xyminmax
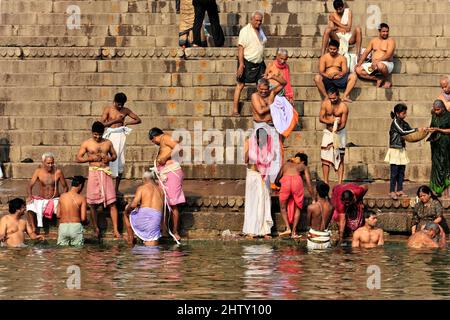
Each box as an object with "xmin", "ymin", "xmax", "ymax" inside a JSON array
[{"xmin": 0, "ymin": 0, "xmax": 450, "ymax": 181}]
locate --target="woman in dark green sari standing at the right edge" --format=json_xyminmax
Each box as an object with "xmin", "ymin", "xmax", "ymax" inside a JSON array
[{"xmin": 427, "ymin": 100, "xmax": 450, "ymax": 197}]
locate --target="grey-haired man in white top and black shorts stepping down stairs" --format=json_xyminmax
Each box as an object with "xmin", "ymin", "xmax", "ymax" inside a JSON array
[{"xmin": 232, "ymin": 11, "xmax": 267, "ymax": 116}]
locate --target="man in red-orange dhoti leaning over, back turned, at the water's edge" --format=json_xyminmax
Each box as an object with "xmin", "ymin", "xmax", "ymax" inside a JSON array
[{"xmin": 275, "ymin": 153, "xmax": 314, "ymax": 239}]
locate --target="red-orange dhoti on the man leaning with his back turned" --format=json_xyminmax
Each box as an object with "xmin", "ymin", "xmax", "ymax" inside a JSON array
[{"xmin": 279, "ymin": 175, "xmax": 305, "ymax": 224}]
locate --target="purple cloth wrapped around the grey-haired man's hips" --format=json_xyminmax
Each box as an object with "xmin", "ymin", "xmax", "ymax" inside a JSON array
[{"xmin": 130, "ymin": 208, "xmax": 162, "ymax": 241}]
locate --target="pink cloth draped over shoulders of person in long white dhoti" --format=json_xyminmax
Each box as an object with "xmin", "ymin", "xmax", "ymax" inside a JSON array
[{"xmin": 248, "ymin": 131, "xmax": 275, "ymax": 180}]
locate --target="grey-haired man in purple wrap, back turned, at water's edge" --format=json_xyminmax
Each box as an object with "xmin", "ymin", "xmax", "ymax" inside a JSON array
[{"xmin": 123, "ymin": 171, "xmax": 164, "ymax": 246}]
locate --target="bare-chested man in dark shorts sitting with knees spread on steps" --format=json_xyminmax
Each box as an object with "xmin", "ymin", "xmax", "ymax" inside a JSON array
[{"xmin": 314, "ymin": 40, "xmax": 358, "ymax": 102}]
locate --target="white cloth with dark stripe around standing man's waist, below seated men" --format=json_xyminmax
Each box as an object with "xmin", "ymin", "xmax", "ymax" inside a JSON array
[{"xmin": 320, "ymin": 128, "xmax": 346, "ymax": 170}]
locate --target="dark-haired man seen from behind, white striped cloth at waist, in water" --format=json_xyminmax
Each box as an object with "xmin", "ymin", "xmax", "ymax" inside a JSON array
[{"xmin": 306, "ymin": 181, "xmax": 333, "ymax": 250}]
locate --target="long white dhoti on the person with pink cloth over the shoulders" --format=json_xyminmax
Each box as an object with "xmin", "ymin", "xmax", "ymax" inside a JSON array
[{"xmin": 242, "ymin": 169, "xmax": 273, "ymax": 236}]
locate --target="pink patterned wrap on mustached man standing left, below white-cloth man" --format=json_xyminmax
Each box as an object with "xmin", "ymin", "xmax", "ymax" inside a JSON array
[{"xmin": 86, "ymin": 170, "xmax": 116, "ymax": 207}]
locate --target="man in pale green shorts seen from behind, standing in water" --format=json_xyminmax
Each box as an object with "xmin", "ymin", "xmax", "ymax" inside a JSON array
[{"xmin": 56, "ymin": 176, "xmax": 87, "ymax": 246}]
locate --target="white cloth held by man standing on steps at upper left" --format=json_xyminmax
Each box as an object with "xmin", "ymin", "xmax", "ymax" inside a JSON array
[{"xmin": 103, "ymin": 126, "xmax": 133, "ymax": 178}]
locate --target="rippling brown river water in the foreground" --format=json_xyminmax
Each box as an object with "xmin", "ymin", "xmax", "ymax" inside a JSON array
[{"xmin": 0, "ymin": 241, "xmax": 450, "ymax": 299}]
